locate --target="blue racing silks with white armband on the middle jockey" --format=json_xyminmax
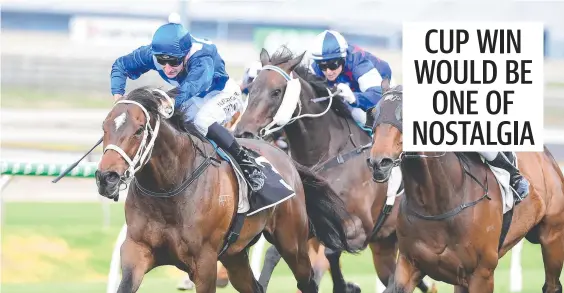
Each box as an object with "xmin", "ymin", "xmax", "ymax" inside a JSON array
[{"xmin": 310, "ymin": 45, "xmax": 392, "ymax": 111}]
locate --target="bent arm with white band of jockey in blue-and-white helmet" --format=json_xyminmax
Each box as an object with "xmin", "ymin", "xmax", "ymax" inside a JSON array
[{"xmin": 353, "ymin": 59, "xmax": 391, "ymax": 111}]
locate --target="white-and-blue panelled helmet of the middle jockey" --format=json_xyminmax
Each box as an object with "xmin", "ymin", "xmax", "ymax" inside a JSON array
[{"xmin": 310, "ymin": 30, "xmax": 348, "ymax": 61}]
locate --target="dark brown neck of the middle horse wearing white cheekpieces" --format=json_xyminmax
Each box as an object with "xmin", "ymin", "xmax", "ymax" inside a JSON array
[{"xmin": 284, "ymin": 86, "xmax": 370, "ymax": 166}]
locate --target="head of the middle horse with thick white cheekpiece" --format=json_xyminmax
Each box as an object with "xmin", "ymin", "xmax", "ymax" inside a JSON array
[{"xmin": 235, "ymin": 49, "xmax": 305, "ymax": 138}]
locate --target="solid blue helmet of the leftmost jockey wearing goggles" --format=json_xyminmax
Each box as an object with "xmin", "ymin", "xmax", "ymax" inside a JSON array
[{"xmin": 151, "ymin": 23, "xmax": 192, "ymax": 58}]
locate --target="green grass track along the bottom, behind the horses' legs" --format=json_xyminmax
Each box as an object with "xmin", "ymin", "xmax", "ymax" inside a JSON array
[{"xmin": 1, "ymin": 202, "xmax": 564, "ymax": 293}]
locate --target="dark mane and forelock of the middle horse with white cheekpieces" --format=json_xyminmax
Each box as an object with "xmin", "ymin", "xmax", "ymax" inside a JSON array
[{"xmin": 270, "ymin": 45, "xmax": 353, "ymax": 119}]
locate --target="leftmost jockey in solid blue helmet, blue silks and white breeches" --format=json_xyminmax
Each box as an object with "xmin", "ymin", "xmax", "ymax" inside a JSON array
[{"xmin": 111, "ymin": 22, "xmax": 274, "ymax": 191}]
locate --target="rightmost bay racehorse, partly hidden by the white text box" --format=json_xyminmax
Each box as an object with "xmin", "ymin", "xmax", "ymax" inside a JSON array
[{"xmin": 368, "ymin": 86, "xmax": 564, "ymax": 293}]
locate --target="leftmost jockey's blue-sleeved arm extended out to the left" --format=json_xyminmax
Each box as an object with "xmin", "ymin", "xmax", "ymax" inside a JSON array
[{"xmin": 110, "ymin": 46, "xmax": 155, "ymax": 95}]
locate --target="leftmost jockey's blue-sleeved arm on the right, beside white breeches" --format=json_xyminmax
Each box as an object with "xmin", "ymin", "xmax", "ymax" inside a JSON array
[{"xmin": 175, "ymin": 55, "xmax": 214, "ymax": 107}]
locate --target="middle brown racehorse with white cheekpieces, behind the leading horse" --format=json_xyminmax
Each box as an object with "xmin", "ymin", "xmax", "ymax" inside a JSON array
[{"xmin": 235, "ymin": 47, "xmax": 436, "ymax": 292}]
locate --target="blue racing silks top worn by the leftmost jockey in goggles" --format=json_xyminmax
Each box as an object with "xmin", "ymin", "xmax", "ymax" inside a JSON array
[{"xmin": 111, "ymin": 36, "xmax": 229, "ymax": 107}]
